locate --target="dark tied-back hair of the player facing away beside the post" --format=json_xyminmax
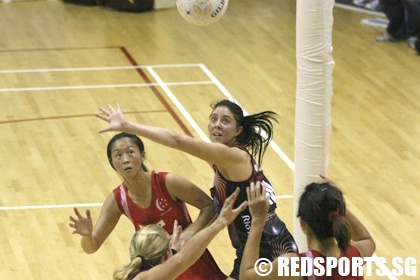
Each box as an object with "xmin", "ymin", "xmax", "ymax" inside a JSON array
[{"xmin": 297, "ymin": 182, "xmax": 351, "ymax": 251}]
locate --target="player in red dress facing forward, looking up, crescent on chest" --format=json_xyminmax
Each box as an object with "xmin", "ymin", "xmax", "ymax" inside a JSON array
[{"xmin": 70, "ymin": 133, "xmax": 227, "ymax": 280}]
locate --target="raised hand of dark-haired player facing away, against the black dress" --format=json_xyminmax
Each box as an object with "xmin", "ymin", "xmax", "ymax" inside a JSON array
[{"xmin": 246, "ymin": 182, "xmax": 269, "ymax": 222}]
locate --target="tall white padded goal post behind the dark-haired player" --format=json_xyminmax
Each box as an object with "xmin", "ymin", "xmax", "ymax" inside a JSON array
[{"xmin": 293, "ymin": 0, "xmax": 334, "ymax": 252}]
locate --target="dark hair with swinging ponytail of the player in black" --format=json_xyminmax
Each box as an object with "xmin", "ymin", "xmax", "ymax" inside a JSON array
[{"xmin": 211, "ymin": 100, "xmax": 278, "ymax": 166}]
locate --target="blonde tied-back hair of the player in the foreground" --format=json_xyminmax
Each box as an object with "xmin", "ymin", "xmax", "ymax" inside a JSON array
[{"xmin": 114, "ymin": 224, "xmax": 170, "ymax": 280}]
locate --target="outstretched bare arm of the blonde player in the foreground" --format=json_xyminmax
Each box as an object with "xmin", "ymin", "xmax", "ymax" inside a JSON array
[{"xmin": 134, "ymin": 189, "xmax": 247, "ymax": 280}]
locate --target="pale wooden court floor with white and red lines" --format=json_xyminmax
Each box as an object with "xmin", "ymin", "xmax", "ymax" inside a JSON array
[{"xmin": 0, "ymin": 0, "xmax": 420, "ymax": 280}]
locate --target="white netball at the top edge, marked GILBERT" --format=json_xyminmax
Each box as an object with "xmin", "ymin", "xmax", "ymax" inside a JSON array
[{"xmin": 176, "ymin": 0, "xmax": 228, "ymax": 26}]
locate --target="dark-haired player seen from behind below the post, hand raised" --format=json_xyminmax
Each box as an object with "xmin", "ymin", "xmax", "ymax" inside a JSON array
[{"xmin": 240, "ymin": 177, "xmax": 375, "ymax": 280}]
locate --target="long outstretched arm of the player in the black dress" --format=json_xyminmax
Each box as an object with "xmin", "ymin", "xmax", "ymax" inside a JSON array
[{"xmin": 95, "ymin": 104, "xmax": 246, "ymax": 166}]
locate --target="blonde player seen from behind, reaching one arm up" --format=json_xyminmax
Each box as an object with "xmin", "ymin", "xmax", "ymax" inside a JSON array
[{"xmin": 114, "ymin": 186, "xmax": 247, "ymax": 280}]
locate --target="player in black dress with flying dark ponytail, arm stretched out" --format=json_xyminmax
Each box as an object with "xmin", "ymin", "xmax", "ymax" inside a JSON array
[{"xmin": 96, "ymin": 100, "xmax": 297, "ymax": 279}]
